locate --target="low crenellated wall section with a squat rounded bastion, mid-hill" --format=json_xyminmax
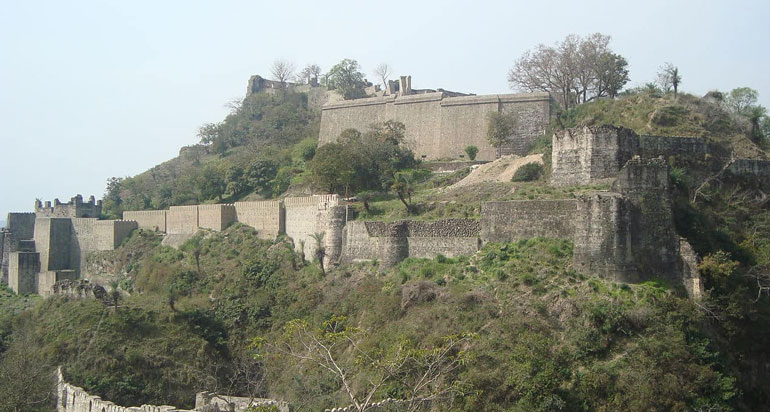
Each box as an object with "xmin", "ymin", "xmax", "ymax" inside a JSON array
[{"xmin": 341, "ymin": 219, "xmax": 479, "ymax": 267}]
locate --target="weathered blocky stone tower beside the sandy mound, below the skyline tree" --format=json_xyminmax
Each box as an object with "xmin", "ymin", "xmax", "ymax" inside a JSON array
[{"xmin": 550, "ymin": 126, "xmax": 639, "ymax": 186}]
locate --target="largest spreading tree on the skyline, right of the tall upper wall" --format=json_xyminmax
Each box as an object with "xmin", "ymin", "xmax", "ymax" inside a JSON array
[{"xmin": 508, "ymin": 33, "xmax": 629, "ymax": 109}]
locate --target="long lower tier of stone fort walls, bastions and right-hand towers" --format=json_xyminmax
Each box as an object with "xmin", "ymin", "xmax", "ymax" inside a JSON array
[{"xmin": 0, "ymin": 126, "xmax": 740, "ymax": 296}]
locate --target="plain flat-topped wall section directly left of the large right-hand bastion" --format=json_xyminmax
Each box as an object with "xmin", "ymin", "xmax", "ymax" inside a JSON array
[{"xmin": 481, "ymin": 199, "xmax": 577, "ymax": 242}]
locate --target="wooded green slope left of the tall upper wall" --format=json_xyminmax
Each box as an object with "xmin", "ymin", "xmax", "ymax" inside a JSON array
[{"xmin": 103, "ymin": 89, "xmax": 319, "ymax": 218}]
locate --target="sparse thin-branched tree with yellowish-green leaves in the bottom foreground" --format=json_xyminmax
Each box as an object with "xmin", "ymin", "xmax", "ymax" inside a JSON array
[{"xmin": 262, "ymin": 315, "xmax": 475, "ymax": 412}]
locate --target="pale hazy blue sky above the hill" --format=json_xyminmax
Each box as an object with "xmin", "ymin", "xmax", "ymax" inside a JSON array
[{"xmin": 0, "ymin": 0, "xmax": 770, "ymax": 221}]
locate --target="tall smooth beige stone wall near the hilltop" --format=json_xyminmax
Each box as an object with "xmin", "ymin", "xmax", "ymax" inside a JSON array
[{"xmin": 319, "ymin": 92, "xmax": 551, "ymax": 160}]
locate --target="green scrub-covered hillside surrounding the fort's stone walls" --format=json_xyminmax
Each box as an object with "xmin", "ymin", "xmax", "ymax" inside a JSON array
[{"xmin": 0, "ymin": 84, "xmax": 770, "ymax": 412}]
